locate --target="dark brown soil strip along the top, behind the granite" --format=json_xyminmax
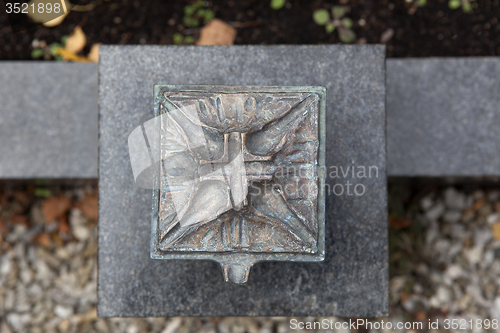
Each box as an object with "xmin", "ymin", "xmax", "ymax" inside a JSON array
[{"xmin": 0, "ymin": 0, "xmax": 500, "ymax": 60}]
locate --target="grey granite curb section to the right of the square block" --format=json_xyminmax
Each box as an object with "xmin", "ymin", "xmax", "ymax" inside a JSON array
[{"xmin": 387, "ymin": 57, "xmax": 500, "ymax": 176}]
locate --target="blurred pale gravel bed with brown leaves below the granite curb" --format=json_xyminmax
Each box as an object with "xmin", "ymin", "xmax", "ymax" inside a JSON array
[{"xmin": 0, "ymin": 183, "xmax": 500, "ymax": 333}]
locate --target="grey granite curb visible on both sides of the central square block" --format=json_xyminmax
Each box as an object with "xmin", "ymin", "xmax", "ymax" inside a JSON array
[{"xmin": 0, "ymin": 57, "xmax": 500, "ymax": 179}]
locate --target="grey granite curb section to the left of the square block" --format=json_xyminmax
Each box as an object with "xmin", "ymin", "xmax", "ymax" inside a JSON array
[{"xmin": 0, "ymin": 61, "xmax": 97, "ymax": 178}]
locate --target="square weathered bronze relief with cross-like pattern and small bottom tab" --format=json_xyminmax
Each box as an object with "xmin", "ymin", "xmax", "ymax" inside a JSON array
[{"xmin": 149, "ymin": 85, "xmax": 326, "ymax": 284}]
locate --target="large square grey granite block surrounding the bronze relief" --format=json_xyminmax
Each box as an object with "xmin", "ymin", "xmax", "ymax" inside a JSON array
[{"xmin": 98, "ymin": 45, "xmax": 388, "ymax": 316}]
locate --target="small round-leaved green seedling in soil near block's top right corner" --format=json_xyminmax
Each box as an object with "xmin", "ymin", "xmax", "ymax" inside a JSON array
[{"xmin": 313, "ymin": 6, "xmax": 356, "ymax": 43}]
